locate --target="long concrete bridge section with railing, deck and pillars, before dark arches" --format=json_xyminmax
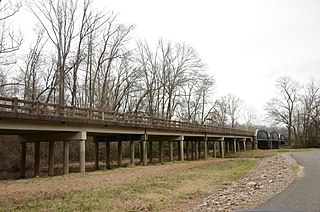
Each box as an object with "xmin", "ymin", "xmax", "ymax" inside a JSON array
[{"xmin": 0, "ymin": 97, "xmax": 257, "ymax": 177}]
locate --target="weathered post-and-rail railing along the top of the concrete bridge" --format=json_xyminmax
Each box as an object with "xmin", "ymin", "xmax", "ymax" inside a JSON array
[{"xmin": 0, "ymin": 97, "xmax": 254, "ymax": 136}]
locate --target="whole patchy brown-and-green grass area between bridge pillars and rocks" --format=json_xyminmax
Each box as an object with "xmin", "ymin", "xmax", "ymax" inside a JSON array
[{"xmin": 0, "ymin": 159, "xmax": 257, "ymax": 211}]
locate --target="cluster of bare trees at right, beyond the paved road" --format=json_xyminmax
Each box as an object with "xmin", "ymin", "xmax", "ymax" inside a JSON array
[{"xmin": 266, "ymin": 77, "xmax": 320, "ymax": 147}]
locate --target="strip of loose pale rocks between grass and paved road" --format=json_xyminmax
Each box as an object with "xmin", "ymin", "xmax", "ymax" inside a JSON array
[{"xmin": 190, "ymin": 153, "xmax": 298, "ymax": 211}]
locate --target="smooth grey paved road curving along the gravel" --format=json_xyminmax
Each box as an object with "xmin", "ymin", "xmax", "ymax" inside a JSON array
[{"xmin": 261, "ymin": 151, "xmax": 320, "ymax": 212}]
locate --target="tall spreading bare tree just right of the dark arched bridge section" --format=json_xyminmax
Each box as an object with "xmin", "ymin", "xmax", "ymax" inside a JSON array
[{"xmin": 265, "ymin": 77, "xmax": 300, "ymax": 145}]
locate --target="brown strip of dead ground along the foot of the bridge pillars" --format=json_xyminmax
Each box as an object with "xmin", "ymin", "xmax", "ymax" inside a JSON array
[{"xmin": 0, "ymin": 159, "xmax": 228, "ymax": 206}]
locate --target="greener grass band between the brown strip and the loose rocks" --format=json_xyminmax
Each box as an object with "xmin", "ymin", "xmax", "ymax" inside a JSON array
[{"xmin": 0, "ymin": 158, "xmax": 257, "ymax": 211}]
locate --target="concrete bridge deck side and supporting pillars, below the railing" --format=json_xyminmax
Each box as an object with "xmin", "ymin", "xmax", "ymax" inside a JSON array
[{"xmin": 0, "ymin": 117, "xmax": 252, "ymax": 177}]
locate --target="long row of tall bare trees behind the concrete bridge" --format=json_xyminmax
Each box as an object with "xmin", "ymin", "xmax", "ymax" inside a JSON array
[{"xmin": 0, "ymin": 0, "xmax": 250, "ymax": 128}]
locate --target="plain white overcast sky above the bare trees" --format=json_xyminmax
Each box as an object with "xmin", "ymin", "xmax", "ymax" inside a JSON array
[{"xmin": 16, "ymin": 0, "xmax": 320, "ymax": 119}]
